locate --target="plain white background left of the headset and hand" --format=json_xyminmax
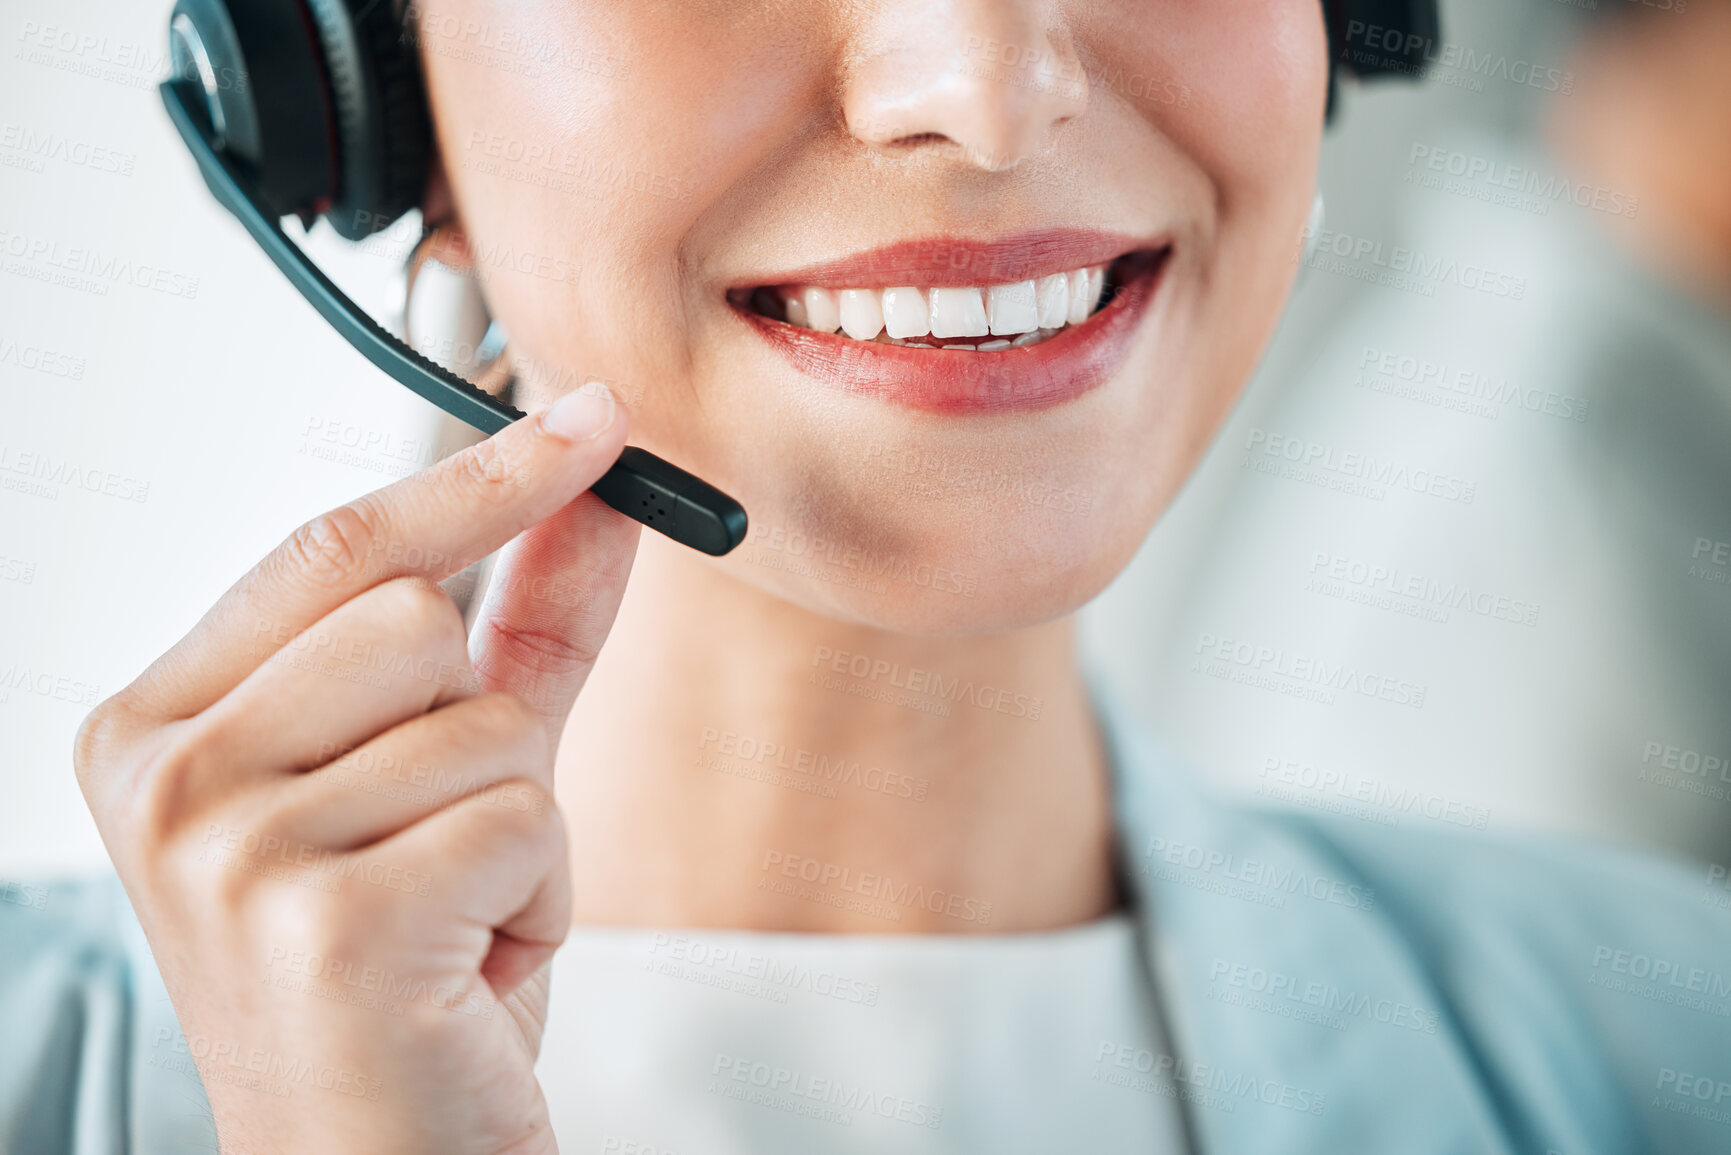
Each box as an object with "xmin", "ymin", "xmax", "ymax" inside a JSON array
[{"xmin": 0, "ymin": 0, "xmax": 438, "ymax": 873}]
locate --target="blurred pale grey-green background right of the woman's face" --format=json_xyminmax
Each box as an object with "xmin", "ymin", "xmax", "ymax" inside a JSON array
[{"xmin": 1085, "ymin": 0, "xmax": 1731, "ymax": 862}]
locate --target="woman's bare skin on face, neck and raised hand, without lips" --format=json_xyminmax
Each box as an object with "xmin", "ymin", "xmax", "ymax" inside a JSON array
[{"xmin": 74, "ymin": 0, "xmax": 1326, "ymax": 1153}]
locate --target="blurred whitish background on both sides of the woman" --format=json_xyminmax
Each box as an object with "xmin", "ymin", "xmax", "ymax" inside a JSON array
[{"xmin": 0, "ymin": 0, "xmax": 1731, "ymax": 873}]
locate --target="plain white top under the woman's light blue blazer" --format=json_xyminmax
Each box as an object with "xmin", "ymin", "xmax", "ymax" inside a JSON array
[{"xmin": 535, "ymin": 914, "xmax": 1187, "ymax": 1155}]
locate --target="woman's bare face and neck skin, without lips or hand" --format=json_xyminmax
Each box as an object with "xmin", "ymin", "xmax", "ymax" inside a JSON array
[{"xmin": 422, "ymin": 0, "xmax": 1326, "ymax": 932}]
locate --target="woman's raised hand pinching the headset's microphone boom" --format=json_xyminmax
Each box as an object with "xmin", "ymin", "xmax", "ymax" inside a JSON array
[{"xmin": 76, "ymin": 386, "xmax": 639, "ymax": 1155}]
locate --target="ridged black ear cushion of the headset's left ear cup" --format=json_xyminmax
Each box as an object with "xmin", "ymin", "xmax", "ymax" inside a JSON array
[{"xmin": 306, "ymin": 0, "xmax": 433, "ymax": 241}]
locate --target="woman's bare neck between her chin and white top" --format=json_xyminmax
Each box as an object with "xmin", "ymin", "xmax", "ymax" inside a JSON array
[{"xmin": 557, "ymin": 533, "xmax": 1116, "ymax": 933}]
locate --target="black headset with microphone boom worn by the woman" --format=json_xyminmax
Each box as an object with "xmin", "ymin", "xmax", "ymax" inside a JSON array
[{"xmin": 161, "ymin": 0, "xmax": 1437, "ymax": 556}]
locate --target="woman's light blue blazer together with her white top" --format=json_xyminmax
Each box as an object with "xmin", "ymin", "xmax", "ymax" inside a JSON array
[{"xmin": 0, "ymin": 687, "xmax": 1731, "ymax": 1155}]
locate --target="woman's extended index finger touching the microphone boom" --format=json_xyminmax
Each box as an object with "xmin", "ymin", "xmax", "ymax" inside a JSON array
[{"xmin": 121, "ymin": 386, "xmax": 625, "ymax": 719}]
